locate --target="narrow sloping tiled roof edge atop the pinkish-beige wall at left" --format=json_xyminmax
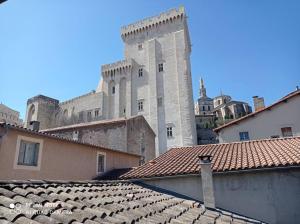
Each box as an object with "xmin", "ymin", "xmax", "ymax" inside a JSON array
[{"xmin": 0, "ymin": 122, "xmax": 140, "ymax": 157}]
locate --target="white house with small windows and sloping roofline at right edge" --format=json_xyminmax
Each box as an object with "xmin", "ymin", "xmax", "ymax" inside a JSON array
[{"xmin": 214, "ymin": 91, "xmax": 300, "ymax": 143}]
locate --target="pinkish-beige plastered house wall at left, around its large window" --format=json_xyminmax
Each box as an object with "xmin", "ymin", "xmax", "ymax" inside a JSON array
[{"xmin": 0, "ymin": 128, "xmax": 140, "ymax": 180}]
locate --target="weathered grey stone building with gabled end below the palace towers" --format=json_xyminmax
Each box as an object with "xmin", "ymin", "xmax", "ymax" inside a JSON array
[{"xmin": 42, "ymin": 116, "xmax": 155, "ymax": 163}]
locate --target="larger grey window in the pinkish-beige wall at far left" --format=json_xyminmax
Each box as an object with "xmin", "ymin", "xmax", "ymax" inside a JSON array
[{"xmin": 17, "ymin": 140, "xmax": 40, "ymax": 166}]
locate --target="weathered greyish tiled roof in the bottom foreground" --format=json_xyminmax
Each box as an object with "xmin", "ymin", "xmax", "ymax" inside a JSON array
[{"xmin": 0, "ymin": 182, "xmax": 261, "ymax": 224}]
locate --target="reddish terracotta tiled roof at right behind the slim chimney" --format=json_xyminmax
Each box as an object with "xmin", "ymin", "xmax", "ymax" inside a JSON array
[{"xmin": 121, "ymin": 137, "xmax": 300, "ymax": 179}]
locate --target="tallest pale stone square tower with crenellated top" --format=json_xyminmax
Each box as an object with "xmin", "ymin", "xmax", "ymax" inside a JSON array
[{"xmin": 114, "ymin": 7, "xmax": 196, "ymax": 154}]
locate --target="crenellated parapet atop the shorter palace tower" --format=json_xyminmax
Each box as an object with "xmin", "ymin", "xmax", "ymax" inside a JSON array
[{"xmin": 101, "ymin": 59, "xmax": 132, "ymax": 77}]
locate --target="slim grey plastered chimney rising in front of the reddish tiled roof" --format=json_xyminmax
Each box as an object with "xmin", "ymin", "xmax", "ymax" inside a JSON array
[{"xmin": 199, "ymin": 155, "xmax": 215, "ymax": 208}]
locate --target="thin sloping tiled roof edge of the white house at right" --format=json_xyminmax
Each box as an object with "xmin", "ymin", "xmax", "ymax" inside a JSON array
[{"xmin": 214, "ymin": 90, "xmax": 300, "ymax": 132}]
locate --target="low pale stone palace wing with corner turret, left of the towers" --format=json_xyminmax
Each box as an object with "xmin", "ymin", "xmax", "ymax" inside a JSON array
[{"xmin": 25, "ymin": 91, "xmax": 105, "ymax": 129}]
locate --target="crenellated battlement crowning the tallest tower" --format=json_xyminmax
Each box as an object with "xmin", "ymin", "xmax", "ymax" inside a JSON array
[{"xmin": 121, "ymin": 7, "xmax": 185, "ymax": 39}]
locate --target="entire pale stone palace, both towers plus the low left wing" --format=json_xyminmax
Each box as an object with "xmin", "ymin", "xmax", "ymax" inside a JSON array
[{"xmin": 26, "ymin": 7, "xmax": 196, "ymax": 155}]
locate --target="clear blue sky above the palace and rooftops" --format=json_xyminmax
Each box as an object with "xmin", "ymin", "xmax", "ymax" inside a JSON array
[{"xmin": 0, "ymin": 0, "xmax": 300, "ymax": 118}]
